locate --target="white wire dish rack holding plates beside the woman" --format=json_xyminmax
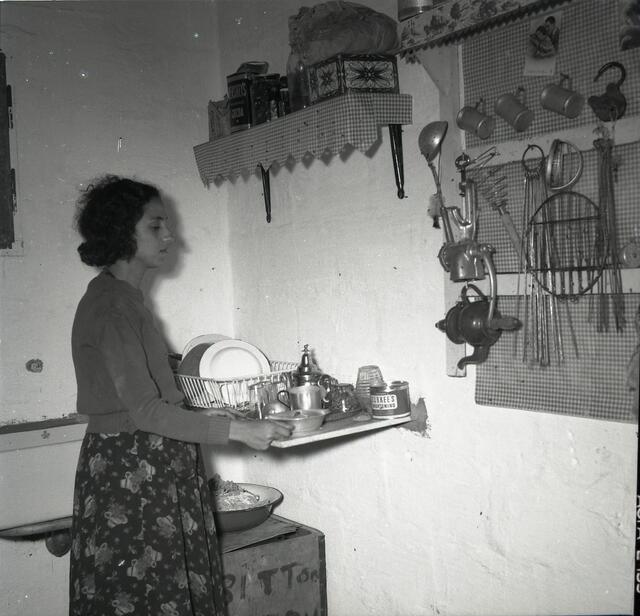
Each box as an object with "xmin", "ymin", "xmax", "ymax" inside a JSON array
[{"xmin": 175, "ymin": 361, "xmax": 298, "ymax": 410}]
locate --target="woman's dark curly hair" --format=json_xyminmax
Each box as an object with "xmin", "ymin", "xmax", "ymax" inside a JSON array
[{"xmin": 76, "ymin": 175, "xmax": 160, "ymax": 267}]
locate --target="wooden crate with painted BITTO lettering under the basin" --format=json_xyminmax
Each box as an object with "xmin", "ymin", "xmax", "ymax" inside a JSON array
[{"xmin": 222, "ymin": 523, "xmax": 327, "ymax": 616}]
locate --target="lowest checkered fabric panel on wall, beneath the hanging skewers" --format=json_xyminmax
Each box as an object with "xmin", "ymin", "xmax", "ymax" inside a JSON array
[{"xmin": 476, "ymin": 293, "xmax": 640, "ymax": 422}]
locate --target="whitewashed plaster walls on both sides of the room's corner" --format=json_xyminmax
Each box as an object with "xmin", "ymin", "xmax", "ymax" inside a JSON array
[{"xmin": 0, "ymin": 0, "xmax": 636, "ymax": 616}]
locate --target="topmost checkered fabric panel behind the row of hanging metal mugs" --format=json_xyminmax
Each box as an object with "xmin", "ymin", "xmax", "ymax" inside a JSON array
[{"xmin": 462, "ymin": 0, "xmax": 640, "ymax": 147}]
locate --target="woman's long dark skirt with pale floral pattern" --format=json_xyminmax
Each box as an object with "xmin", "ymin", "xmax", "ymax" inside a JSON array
[{"xmin": 69, "ymin": 431, "xmax": 226, "ymax": 616}]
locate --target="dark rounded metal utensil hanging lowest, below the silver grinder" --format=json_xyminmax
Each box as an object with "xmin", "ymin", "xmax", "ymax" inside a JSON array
[{"xmin": 436, "ymin": 284, "xmax": 522, "ymax": 369}]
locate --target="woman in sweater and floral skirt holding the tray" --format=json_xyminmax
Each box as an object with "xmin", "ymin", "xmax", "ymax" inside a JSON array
[{"xmin": 70, "ymin": 176, "xmax": 290, "ymax": 616}]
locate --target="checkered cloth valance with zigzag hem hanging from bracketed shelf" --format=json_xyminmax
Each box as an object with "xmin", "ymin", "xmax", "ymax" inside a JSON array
[{"xmin": 194, "ymin": 92, "xmax": 412, "ymax": 185}]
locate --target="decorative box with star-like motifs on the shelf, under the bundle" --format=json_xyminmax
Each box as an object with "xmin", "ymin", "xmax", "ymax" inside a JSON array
[{"xmin": 308, "ymin": 54, "xmax": 399, "ymax": 103}]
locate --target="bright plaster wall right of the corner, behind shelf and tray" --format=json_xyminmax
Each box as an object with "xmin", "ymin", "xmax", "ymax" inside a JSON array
[{"xmin": 214, "ymin": 2, "xmax": 636, "ymax": 616}]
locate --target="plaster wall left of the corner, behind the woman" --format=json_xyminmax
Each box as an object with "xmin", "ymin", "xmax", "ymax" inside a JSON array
[{"xmin": 0, "ymin": 1, "xmax": 238, "ymax": 616}]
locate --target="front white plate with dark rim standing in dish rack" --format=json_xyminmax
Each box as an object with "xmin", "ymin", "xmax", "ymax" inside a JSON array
[{"xmin": 200, "ymin": 339, "xmax": 271, "ymax": 381}]
